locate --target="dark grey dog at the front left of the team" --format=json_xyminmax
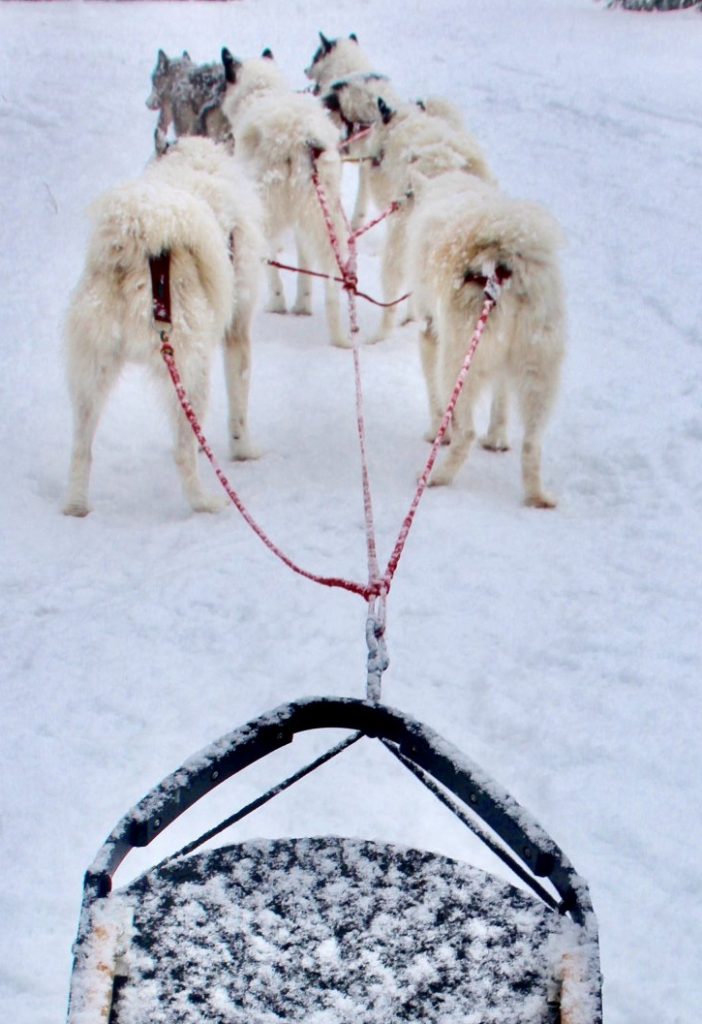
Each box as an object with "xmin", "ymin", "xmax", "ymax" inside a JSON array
[{"xmin": 146, "ymin": 50, "xmax": 232, "ymax": 156}]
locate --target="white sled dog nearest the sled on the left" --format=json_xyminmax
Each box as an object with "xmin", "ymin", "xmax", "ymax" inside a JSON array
[{"xmin": 63, "ymin": 138, "xmax": 264, "ymax": 516}]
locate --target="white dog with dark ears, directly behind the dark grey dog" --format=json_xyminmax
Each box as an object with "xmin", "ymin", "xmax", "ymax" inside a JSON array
[{"xmin": 222, "ymin": 48, "xmax": 350, "ymax": 347}]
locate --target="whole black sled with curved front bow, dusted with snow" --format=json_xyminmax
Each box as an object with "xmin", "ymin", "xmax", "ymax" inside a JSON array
[{"xmin": 69, "ymin": 698, "xmax": 602, "ymax": 1024}]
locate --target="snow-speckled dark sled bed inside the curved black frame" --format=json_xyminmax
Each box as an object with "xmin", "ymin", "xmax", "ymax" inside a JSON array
[{"xmin": 111, "ymin": 838, "xmax": 572, "ymax": 1024}]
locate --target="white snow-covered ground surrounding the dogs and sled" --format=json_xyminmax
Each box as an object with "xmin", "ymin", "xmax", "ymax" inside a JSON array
[{"xmin": 0, "ymin": 0, "xmax": 702, "ymax": 1024}]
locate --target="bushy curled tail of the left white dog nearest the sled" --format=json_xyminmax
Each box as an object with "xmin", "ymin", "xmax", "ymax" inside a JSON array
[{"xmin": 88, "ymin": 181, "xmax": 234, "ymax": 331}]
